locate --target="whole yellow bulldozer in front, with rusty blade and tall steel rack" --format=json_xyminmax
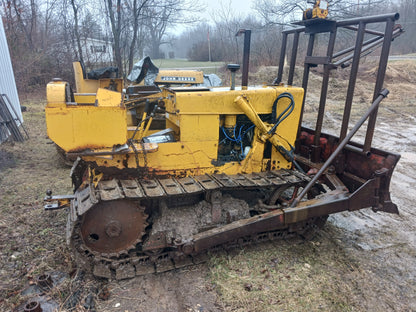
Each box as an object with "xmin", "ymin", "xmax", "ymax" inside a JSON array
[{"xmin": 45, "ymin": 14, "xmax": 402, "ymax": 279}]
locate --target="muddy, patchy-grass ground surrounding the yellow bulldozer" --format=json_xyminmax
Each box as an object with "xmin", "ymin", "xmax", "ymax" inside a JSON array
[{"xmin": 0, "ymin": 61, "xmax": 416, "ymax": 312}]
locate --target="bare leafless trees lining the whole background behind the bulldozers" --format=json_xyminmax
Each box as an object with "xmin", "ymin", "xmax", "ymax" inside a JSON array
[{"xmin": 1, "ymin": 0, "xmax": 416, "ymax": 91}]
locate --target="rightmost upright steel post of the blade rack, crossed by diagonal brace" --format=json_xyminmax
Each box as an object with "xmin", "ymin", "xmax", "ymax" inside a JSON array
[{"xmin": 363, "ymin": 17, "xmax": 395, "ymax": 152}]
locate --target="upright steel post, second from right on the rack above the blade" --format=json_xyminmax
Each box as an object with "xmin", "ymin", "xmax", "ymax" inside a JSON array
[{"xmin": 339, "ymin": 22, "xmax": 366, "ymax": 141}]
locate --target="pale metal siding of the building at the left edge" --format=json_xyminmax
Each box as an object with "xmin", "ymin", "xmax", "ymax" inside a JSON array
[{"xmin": 0, "ymin": 18, "xmax": 23, "ymax": 142}]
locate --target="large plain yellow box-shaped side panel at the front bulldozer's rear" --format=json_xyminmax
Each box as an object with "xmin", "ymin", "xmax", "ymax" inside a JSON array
[{"xmin": 45, "ymin": 106, "xmax": 127, "ymax": 152}]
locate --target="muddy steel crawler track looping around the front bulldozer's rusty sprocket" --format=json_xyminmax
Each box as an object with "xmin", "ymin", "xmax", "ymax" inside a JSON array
[{"xmin": 67, "ymin": 170, "xmax": 322, "ymax": 280}]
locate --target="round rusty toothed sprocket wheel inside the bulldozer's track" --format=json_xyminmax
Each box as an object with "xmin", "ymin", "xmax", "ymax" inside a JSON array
[{"xmin": 81, "ymin": 199, "xmax": 147, "ymax": 257}]
